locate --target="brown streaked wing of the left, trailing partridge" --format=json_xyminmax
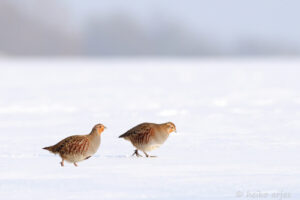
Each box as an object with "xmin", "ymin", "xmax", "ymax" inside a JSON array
[{"xmin": 53, "ymin": 135, "xmax": 89, "ymax": 155}]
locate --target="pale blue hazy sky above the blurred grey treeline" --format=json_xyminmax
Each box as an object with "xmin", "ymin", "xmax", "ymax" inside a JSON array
[{"xmin": 64, "ymin": 0, "xmax": 300, "ymax": 42}]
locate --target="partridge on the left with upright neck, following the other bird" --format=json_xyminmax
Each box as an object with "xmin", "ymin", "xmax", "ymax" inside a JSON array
[{"xmin": 43, "ymin": 124, "xmax": 106, "ymax": 167}]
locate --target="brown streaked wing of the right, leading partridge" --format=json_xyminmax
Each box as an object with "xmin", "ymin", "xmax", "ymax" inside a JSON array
[{"xmin": 119, "ymin": 123, "xmax": 153, "ymax": 144}]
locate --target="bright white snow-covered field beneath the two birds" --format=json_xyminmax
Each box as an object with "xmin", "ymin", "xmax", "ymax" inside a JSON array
[{"xmin": 0, "ymin": 59, "xmax": 300, "ymax": 200}]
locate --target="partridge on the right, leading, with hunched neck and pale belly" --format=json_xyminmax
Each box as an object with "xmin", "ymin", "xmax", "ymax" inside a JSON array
[{"xmin": 119, "ymin": 122, "xmax": 176, "ymax": 157}]
